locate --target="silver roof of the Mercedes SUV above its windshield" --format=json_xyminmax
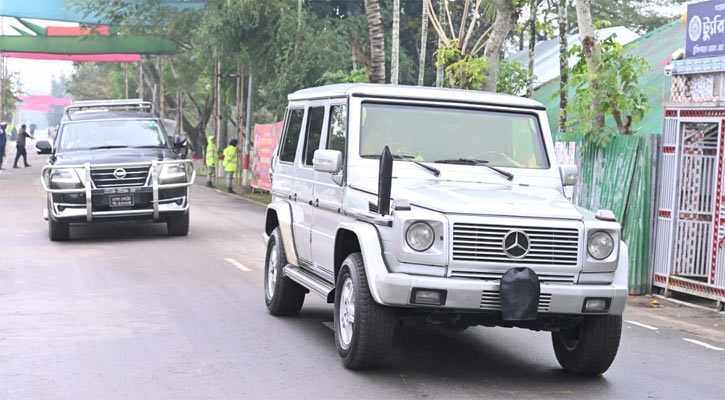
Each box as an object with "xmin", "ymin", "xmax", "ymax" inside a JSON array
[{"xmin": 287, "ymin": 83, "xmax": 546, "ymax": 110}]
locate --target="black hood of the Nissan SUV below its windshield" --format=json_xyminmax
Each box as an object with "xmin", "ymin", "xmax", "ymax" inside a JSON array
[{"xmin": 53, "ymin": 148, "xmax": 177, "ymax": 165}]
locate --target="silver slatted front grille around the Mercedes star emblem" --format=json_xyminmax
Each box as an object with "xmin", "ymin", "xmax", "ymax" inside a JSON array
[{"xmin": 453, "ymin": 223, "xmax": 579, "ymax": 265}]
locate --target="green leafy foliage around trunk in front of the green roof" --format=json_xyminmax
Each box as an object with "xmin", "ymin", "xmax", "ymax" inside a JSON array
[{"xmin": 566, "ymin": 35, "xmax": 649, "ymax": 147}]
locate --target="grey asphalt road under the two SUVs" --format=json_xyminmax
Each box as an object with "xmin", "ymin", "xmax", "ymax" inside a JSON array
[{"xmin": 0, "ymin": 146, "xmax": 725, "ymax": 399}]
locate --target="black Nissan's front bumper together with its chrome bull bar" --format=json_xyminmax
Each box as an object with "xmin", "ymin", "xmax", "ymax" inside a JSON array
[{"xmin": 41, "ymin": 160, "xmax": 196, "ymax": 222}]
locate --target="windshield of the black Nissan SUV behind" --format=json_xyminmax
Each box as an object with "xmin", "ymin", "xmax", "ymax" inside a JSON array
[{"xmin": 58, "ymin": 120, "xmax": 166, "ymax": 151}]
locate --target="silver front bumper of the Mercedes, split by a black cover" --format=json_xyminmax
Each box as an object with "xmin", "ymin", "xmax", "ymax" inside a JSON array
[{"xmin": 375, "ymin": 273, "xmax": 627, "ymax": 315}]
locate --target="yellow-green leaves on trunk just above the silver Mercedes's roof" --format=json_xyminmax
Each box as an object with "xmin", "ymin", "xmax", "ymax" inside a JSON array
[{"xmin": 435, "ymin": 39, "xmax": 488, "ymax": 90}]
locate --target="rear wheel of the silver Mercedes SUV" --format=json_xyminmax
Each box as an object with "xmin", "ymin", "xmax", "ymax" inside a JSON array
[{"xmin": 264, "ymin": 227, "xmax": 306, "ymax": 316}]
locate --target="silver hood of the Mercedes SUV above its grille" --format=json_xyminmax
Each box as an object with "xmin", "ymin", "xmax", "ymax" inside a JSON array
[{"xmin": 354, "ymin": 178, "xmax": 583, "ymax": 220}]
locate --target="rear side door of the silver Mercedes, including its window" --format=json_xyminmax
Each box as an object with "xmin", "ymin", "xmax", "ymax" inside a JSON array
[{"xmin": 292, "ymin": 103, "xmax": 325, "ymax": 268}]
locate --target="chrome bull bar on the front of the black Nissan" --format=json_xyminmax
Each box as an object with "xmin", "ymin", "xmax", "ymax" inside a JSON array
[{"xmin": 40, "ymin": 160, "xmax": 196, "ymax": 222}]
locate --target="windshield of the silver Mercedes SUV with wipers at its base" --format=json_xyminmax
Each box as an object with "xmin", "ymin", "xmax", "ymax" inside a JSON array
[{"xmin": 360, "ymin": 103, "xmax": 549, "ymax": 169}]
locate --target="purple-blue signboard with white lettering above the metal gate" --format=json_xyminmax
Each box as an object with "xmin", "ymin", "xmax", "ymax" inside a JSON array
[{"xmin": 685, "ymin": 0, "xmax": 725, "ymax": 58}]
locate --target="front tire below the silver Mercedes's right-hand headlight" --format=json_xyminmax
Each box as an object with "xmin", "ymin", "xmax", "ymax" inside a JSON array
[{"xmin": 551, "ymin": 315, "xmax": 622, "ymax": 375}]
